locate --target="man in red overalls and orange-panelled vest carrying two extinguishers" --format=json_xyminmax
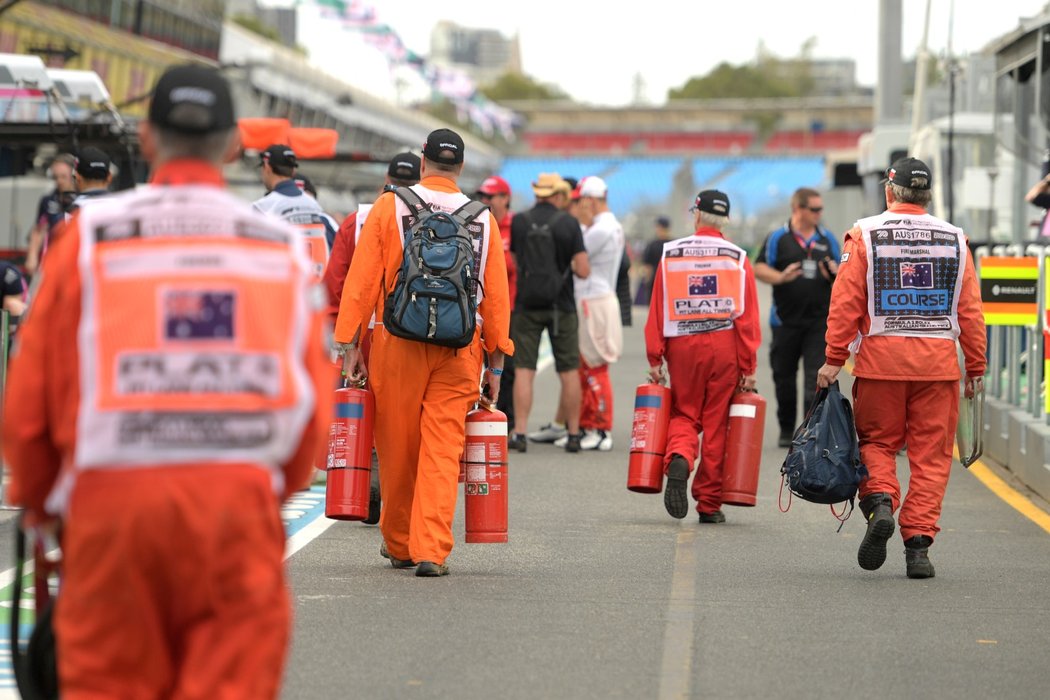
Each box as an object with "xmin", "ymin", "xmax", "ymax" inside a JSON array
[{"xmin": 646, "ymin": 190, "xmax": 761, "ymax": 523}]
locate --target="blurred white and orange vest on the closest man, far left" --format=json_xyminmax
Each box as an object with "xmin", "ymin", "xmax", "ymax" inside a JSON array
[{"xmin": 58, "ymin": 186, "xmax": 319, "ymax": 512}]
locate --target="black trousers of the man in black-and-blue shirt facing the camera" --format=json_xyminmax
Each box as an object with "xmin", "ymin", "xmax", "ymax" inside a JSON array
[{"xmin": 770, "ymin": 319, "xmax": 827, "ymax": 434}]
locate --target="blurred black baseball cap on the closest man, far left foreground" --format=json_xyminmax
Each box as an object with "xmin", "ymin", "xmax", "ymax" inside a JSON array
[{"xmin": 149, "ymin": 64, "xmax": 236, "ymax": 133}]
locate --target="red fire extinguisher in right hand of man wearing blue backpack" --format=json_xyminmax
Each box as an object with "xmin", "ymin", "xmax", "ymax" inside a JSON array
[{"xmin": 460, "ymin": 408, "xmax": 507, "ymax": 544}]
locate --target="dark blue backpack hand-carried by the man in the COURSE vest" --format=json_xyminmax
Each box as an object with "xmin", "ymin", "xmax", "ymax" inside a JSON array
[{"xmin": 780, "ymin": 382, "xmax": 867, "ymax": 521}]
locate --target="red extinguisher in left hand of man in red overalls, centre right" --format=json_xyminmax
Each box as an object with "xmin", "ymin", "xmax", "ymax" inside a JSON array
[{"xmin": 627, "ymin": 384, "xmax": 671, "ymax": 493}]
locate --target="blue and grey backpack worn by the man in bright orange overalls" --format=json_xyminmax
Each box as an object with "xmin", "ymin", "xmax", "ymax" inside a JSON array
[{"xmin": 383, "ymin": 187, "xmax": 488, "ymax": 347}]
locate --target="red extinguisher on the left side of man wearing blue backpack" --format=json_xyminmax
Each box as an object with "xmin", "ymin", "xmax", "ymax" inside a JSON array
[{"xmin": 324, "ymin": 385, "xmax": 376, "ymax": 521}]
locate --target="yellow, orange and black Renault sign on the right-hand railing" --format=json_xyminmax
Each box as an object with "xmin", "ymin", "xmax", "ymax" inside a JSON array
[{"xmin": 981, "ymin": 257, "xmax": 1040, "ymax": 325}]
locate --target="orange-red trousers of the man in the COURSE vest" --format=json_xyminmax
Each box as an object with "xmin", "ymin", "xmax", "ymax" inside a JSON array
[{"xmin": 854, "ymin": 378, "xmax": 959, "ymax": 539}]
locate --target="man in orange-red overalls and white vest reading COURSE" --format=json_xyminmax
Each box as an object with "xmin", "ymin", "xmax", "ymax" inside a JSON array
[{"xmin": 817, "ymin": 157, "xmax": 986, "ymax": 578}]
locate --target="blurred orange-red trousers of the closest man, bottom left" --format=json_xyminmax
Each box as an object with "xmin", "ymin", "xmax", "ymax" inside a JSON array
[{"xmin": 55, "ymin": 464, "xmax": 291, "ymax": 700}]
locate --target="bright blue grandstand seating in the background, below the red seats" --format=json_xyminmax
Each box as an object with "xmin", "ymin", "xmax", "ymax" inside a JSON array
[{"xmin": 500, "ymin": 155, "xmax": 824, "ymax": 218}]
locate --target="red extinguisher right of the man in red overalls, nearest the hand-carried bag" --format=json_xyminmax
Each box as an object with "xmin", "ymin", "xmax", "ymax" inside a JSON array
[{"xmin": 722, "ymin": 391, "xmax": 765, "ymax": 506}]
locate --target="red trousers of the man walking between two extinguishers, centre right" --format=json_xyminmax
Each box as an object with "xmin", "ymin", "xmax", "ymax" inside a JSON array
[{"xmin": 665, "ymin": 331, "xmax": 740, "ymax": 513}]
